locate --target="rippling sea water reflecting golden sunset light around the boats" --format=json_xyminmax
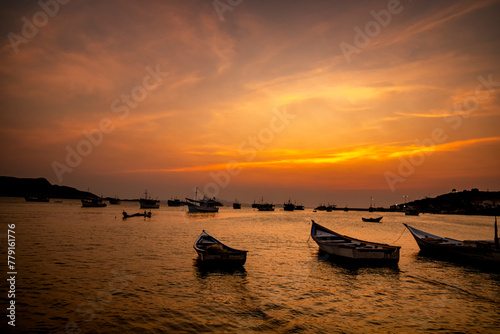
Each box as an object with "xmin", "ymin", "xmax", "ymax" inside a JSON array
[{"xmin": 0, "ymin": 198, "xmax": 500, "ymax": 333}]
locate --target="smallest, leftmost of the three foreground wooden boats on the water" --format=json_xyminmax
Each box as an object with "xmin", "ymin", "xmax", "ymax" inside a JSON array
[{"xmin": 193, "ymin": 230, "xmax": 248, "ymax": 266}]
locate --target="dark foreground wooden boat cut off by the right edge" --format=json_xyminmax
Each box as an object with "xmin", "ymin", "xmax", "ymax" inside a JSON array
[{"xmin": 404, "ymin": 222, "xmax": 500, "ymax": 265}]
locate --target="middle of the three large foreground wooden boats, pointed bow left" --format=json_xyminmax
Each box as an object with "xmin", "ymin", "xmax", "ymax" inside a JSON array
[{"xmin": 311, "ymin": 220, "xmax": 401, "ymax": 265}]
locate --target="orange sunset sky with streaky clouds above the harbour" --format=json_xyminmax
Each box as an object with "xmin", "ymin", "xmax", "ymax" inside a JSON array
[{"xmin": 0, "ymin": 0, "xmax": 500, "ymax": 207}]
